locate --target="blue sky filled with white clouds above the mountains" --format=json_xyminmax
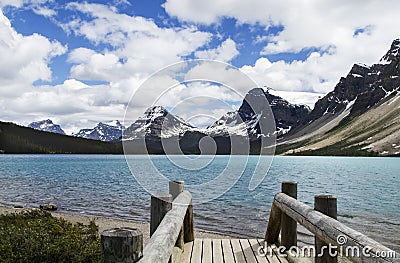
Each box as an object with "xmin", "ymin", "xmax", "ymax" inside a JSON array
[{"xmin": 0, "ymin": 0, "xmax": 400, "ymax": 133}]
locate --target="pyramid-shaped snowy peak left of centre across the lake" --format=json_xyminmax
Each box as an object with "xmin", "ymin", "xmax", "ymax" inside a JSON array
[{"xmin": 123, "ymin": 106, "xmax": 196, "ymax": 139}]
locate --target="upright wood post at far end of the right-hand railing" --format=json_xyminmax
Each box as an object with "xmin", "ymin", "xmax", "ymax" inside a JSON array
[{"xmin": 281, "ymin": 182, "xmax": 297, "ymax": 250}]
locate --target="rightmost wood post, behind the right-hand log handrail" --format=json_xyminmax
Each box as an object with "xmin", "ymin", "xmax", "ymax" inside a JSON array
[{"xmin": 314, "ymin": 195, "xmax": 337, "ymax": 263}]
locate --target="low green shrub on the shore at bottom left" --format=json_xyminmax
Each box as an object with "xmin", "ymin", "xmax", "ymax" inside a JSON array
[{"xmin": 0, "ymin": 210, "xmax": 100, "ymax": 262}]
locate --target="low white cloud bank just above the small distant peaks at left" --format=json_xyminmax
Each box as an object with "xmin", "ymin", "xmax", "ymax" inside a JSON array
[{"xmin": 0, "ymin": 79, "xmax": 129, "ymax": 134}]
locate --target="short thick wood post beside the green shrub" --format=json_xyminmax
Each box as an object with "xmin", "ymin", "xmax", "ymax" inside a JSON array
[{"xmin": 100, "ymin": 228, "xmax": 143, "ymax": 263}]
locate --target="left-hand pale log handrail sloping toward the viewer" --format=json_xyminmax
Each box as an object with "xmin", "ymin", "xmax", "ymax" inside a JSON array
[{"xmin": 138, "ymin": 191, "xmax": 192, "ymax": 263}]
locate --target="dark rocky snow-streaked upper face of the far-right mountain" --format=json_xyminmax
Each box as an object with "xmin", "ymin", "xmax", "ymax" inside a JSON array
[{"xmin": 309, "ymin": 39, "xmax": 400, "ymax": 124}]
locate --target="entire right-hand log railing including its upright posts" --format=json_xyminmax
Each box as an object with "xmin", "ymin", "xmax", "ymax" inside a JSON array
[{"xmin": 265, "ymin": 182, "xmax": 400, "ymax": 263}]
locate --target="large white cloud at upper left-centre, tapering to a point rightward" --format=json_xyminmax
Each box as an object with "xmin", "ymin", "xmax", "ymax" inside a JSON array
[{"xmin": 64, "ymin": 3, "xmax": 211, "ymax": 81}]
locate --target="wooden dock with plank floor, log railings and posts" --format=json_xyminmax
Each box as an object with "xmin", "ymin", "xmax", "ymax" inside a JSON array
[{"xmin": 101, "ymin": 181, "xmax": 400, "ymax": 263}]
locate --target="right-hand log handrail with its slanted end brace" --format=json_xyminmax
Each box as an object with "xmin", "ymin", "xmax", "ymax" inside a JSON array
[{"xmin": 266, "ymin": 193, "xmax": 399, "ymax": 262}]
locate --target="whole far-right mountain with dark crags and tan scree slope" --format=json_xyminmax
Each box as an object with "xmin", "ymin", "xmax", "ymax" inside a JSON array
[{"xmin": 281, "ymin": 39, "xmax": 400, "ymax": 155}]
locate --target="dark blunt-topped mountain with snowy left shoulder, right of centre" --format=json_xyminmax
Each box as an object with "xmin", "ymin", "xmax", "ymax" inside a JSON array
[{"xmin": 206, "ymin": 88, "xmax": 310, "ymax": 138}]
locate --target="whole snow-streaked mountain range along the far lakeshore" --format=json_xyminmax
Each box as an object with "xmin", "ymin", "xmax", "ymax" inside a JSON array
[{"xmin": 4, "ymin": 39, "xmax": 400, "ymax": 156}]
